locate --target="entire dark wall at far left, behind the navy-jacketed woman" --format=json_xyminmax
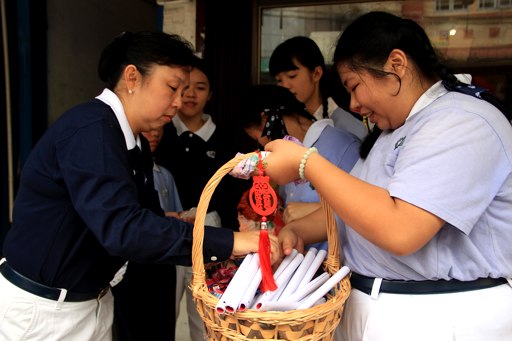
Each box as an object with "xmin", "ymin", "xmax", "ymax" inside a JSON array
[{"xmin": 0, "ymin": 0, "xmax": 162, "ymax": 257}]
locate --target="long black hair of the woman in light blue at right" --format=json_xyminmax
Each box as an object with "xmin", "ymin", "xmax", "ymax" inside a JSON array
[{"xmin": 333, "ymin": 11, "xmax": 512, "ymax": 158}]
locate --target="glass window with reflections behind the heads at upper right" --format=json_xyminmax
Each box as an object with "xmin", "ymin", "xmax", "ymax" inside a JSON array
[{"xmin": 258, "ymin": 0, "xmax": 512, "ymax": 103}]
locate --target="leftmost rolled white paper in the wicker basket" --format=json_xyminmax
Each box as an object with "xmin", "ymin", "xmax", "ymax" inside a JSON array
[{"xmin": 215, "ymin": 253, "xmax": 259, "ymax": 314}]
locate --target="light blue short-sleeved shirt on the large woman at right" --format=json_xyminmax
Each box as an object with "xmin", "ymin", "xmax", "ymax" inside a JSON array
[{"xmin": 340, "ymin": 82, "xmax": 512, "ymax": 281}]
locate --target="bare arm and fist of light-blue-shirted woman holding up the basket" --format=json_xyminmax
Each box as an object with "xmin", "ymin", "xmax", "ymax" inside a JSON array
[{"xmin": 265, "ymin": 140, "xmax": 444, "ymax": 255}]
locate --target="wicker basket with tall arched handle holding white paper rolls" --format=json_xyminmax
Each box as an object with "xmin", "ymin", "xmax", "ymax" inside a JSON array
[{"xmin": 190, "ymin": 153, "xmax": 350, "ymax": 341}]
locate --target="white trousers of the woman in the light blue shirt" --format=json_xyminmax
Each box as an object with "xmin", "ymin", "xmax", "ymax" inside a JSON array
[{"xmin": 334, "ymin": 284, "xmax": 512, "ymax": 341}]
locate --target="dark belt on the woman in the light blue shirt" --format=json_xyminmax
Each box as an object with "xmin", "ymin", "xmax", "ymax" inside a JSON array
[{"xmin": 350, "ymin": 273, "xmax": 507, "ymax": 295}]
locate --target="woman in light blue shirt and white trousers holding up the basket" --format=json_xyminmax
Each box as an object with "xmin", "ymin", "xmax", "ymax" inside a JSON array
[{"xmin": 265, "ymin": 12, "xmax": 512, "ymax": 341}]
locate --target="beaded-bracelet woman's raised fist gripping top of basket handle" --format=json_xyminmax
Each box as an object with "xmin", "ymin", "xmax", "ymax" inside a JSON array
[{"xmin": 263, "ymin": 140, "xmax": 307, "ymax": 185}]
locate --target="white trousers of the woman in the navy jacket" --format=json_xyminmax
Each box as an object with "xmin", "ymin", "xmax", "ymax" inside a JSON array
[{"xmin": 0, "ymin": 266, "xmax": 114, "ymax": 341}]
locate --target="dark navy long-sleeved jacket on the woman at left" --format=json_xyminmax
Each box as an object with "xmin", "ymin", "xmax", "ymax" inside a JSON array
[{"xmin": 3, "ymin": 99, "xmax": 233, "ymax": 292}]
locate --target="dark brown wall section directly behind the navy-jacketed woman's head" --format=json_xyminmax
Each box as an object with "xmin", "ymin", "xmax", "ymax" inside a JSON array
[{"xmin": 47, "ymin": 0, "xmax": 162, "ymax": 123}]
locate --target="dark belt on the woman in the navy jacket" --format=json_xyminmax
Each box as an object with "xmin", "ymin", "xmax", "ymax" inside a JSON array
[{"xmin": 0, "ymin": 262, "xmax": 109, "ymax": 302}]
